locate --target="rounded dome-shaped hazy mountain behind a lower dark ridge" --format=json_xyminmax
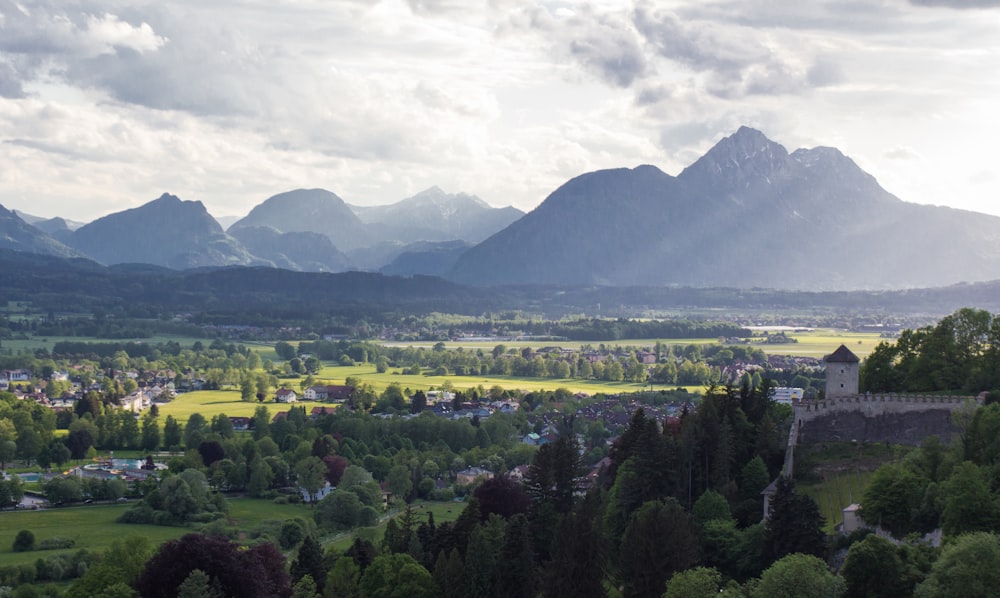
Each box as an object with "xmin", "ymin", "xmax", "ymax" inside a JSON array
[{"xmin": 229, "ymin": 189, "xmax": 370, "ymax": 251}]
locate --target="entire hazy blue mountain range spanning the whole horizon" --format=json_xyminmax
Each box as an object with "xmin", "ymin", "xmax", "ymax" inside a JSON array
[{"xmin": 0, "ymin": 127, "xmax": 1000, "ymax": 290}]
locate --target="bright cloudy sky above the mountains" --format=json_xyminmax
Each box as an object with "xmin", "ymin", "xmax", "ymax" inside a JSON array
[{"xmin": 0, "ymin": 0, "xmax": 1000, "ymax": 221}]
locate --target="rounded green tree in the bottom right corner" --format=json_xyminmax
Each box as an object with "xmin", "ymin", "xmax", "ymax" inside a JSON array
[{"xmin": 913, "ymin": 532, "xmax": 1000, "ymax": 598}]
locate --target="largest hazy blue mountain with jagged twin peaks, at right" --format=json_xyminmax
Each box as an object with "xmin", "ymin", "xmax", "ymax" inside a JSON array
[{"xmin": 449, "ymin": 127, "xmax": 1000, "ymax": 290}]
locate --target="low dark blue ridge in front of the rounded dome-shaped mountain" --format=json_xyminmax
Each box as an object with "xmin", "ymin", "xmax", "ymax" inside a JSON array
[{"xmin": 231, "ymin": 226, "xmax": 351, "ymax": 272}]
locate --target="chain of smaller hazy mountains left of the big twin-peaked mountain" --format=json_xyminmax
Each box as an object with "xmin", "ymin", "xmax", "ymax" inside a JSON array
[{"xmin": 0, "ymin": 187, "xmax": 524, "ymax": 276}]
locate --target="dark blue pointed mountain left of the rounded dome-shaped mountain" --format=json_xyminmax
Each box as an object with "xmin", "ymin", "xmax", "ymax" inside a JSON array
[{"xmin": 70, "ymin": 193, "xmax": 264, "ymax": 269}]
